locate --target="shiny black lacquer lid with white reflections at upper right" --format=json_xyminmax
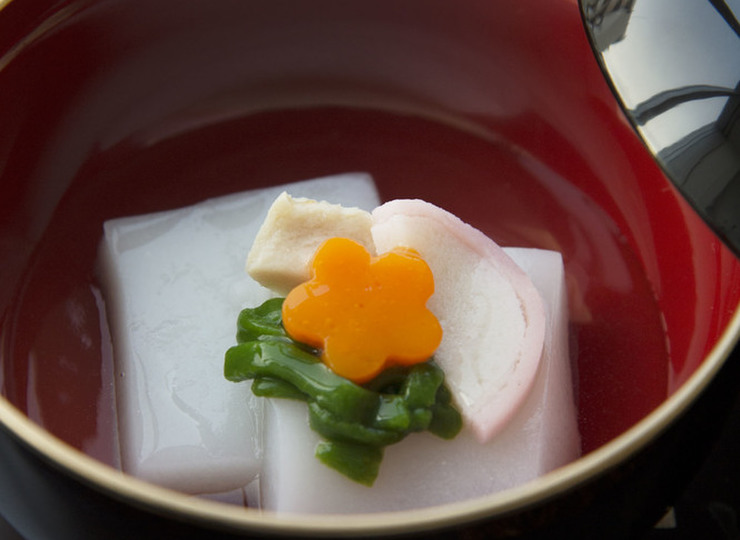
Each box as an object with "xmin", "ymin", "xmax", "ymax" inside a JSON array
[{"xmin": 581, "ymin": 0, "xmax": 740, "ymax": 254}]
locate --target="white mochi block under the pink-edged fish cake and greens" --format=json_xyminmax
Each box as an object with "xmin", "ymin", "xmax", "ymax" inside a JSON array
[{"xmin": 260, "ymin": 248, "xmax": 580, "ymax": 514}]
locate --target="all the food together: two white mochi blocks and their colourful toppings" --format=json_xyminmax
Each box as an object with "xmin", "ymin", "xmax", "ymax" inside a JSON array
[{"xmin": 101, "ymin": 174, "xmax": 580, "ymax": 513}]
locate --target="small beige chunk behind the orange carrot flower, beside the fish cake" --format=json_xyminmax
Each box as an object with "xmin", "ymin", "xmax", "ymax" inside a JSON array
[{"xmin": 246, "ymin": 191, "xmax": 375, "ymax": 295}]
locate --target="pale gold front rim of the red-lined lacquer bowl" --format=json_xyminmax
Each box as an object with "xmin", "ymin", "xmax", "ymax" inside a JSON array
[{"xmin": 0, "ymin": 305, "xmax": 740, "ymax": 536}]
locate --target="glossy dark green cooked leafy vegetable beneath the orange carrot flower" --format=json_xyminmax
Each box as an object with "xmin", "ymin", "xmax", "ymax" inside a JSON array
[{"xmin": 224, "ymin": 298, "xmax": 462, "ymax": 486}]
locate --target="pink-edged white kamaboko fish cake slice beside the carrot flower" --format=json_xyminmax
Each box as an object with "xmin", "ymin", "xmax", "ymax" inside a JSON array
[{"xmin": 372, "ymin": 199, "xmax": 545, "ymax": 443}]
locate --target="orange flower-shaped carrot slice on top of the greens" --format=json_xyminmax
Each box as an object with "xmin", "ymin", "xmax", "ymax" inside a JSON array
[{"xmin": 283, "ymin": 238, "xmax": 442, "ymax": 383}]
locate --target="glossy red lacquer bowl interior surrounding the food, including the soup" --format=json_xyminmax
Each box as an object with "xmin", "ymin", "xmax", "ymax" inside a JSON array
[{"xmin": 0, "ymin": 0, "xmax": 740, "ymax": 520}]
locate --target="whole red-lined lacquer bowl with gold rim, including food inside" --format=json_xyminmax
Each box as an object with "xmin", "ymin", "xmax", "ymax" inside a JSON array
[{"xmin": 0, "ymin": 0, "xmax": 740, "ymax": 538}]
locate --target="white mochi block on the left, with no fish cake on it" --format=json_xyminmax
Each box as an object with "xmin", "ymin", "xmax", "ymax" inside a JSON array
[{"xmin": 99, "ymin": 173, "xmax": 379, "ymax": 498}]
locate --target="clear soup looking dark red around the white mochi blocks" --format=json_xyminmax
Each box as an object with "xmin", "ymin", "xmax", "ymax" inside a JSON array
[{"xmin": 2, "ymin": 108, "xmax": 668, "ymax": 466}]
